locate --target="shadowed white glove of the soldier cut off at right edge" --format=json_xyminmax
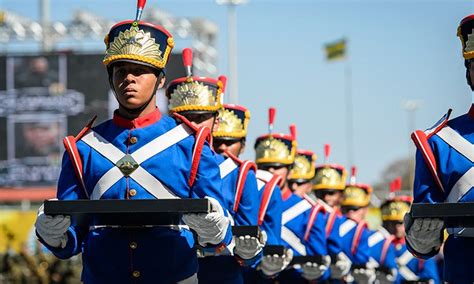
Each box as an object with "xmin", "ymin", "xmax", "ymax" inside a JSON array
[{"xmin": 404, "ymin": 213, "xmax": 444, "ymax": 254}]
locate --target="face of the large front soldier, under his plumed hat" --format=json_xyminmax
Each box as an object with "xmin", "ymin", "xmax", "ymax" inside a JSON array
[{"xmin": 112, "ymin": 62, "xmax": 164, "ymax": 109}]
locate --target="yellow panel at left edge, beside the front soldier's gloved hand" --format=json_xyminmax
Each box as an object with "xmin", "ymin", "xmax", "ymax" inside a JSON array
[{"xmin": 0, "ymin": 210, "xmax": 36, "ymax": 253}]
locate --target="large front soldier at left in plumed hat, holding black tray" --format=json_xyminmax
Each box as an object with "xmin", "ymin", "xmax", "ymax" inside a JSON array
[{"xmin": 35, "ymin": 1, "xmax": 232, "ymax": 283}]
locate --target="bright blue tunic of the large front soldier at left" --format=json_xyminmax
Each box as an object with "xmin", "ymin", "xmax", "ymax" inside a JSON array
[{"xmin": 39, "ymin": 112, "xmax": 232, "ymax": 283}]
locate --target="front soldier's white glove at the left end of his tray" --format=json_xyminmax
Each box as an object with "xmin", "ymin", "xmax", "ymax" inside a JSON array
[{"xmin": 35, "ymin": 205, "xmax": 71, "ymax": 248}]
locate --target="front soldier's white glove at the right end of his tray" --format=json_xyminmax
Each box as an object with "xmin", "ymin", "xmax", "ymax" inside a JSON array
[{"xmin": 183, "ymin": 196, "xmax": 230, "ymax": 246}]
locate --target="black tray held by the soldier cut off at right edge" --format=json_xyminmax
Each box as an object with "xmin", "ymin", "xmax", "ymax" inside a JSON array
[{"xmin": 410, "ymin": 202, "xmax": 474, "ymax": 228}]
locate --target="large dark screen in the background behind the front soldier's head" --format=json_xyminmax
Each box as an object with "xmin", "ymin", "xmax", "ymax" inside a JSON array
[{"xmin": 0, "ymin": 53, "xmax": 185, "ymax": 188}]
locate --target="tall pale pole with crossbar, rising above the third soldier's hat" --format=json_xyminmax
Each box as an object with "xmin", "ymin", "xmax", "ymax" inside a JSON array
[{"xmin": 216, "ymin": 0, "xmax": 248, "ymax": 104}]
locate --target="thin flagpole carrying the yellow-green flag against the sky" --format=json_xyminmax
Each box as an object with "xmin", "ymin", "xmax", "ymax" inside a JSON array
[{"xmin": 344, "ymin": 45, "xmax": 354, "ymax": 167}]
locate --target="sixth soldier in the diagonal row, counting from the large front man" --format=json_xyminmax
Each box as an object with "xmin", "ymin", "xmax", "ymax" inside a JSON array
[{"xmin": 312, "ymin": 144, "xmax": 352, "ymax": 282}]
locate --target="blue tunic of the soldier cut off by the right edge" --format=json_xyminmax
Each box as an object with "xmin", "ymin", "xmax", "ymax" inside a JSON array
[{"xmin": 408, "ymin": 106, "xmax": 474, "ymax": 283}]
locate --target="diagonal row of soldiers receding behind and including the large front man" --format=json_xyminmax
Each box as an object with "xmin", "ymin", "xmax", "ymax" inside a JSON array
[{"xmin": 35, "ymin": 1, "xmax": 466, "ymax": 283}]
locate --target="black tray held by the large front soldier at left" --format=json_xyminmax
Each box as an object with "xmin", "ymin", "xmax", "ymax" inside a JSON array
[{"xmin": 44, "ymin": 199, "xmax": 211, "ymax": 226}]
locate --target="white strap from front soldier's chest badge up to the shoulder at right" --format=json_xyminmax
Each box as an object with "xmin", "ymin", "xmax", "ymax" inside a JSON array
[{"xmin": 131, "ymin": 124, "xmax": 192, "ymax": 164}]
